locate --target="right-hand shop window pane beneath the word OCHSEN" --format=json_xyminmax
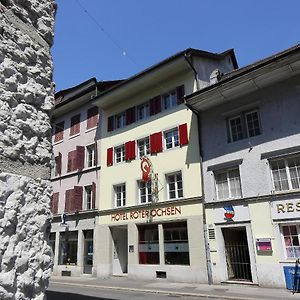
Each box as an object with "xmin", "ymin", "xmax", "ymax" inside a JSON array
[{"xmin": 163, "ymin": 223, "xmax": 190, "ymax": 265}]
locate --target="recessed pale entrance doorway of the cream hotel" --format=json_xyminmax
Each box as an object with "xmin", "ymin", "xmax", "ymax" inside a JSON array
[{"xmin": 110, "ymin": 226, "xmax": 128, "ymax": 275}]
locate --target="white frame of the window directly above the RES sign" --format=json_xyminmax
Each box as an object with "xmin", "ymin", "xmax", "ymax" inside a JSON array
[{"xmin": 269, "ymin": 155, "xmax": 300, "ymax": 192}]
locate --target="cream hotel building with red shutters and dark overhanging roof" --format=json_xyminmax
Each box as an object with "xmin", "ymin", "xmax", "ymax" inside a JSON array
[{"xmin": 93, "ymin": 49, "xmax": 237, "ymax": 282}]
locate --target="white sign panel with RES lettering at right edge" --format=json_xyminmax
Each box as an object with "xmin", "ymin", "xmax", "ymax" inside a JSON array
[{"xmin": 271, "ymin": 200, "xmax": 300, "ymax": 219}]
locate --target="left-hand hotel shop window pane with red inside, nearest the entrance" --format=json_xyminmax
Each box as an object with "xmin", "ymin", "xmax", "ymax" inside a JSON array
[{"xmin": 138, "ymin": 225, "xmax": 159, "ymax": 265}]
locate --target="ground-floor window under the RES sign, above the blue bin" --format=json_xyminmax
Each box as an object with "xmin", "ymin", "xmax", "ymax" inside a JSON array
[{"xmin": 282, "ymin": 225, "xmax": 300, "ymax": 258}]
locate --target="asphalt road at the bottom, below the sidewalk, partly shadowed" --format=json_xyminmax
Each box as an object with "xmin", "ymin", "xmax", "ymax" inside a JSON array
[{"xmin": 47, "ymin": 284, "xmax": 218, "ymax": 300}]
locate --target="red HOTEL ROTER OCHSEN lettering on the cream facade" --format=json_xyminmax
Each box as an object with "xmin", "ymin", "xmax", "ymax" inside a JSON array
[{"xmin": 111, "ymin": 206, "xmax": 181, "ymax": 222}]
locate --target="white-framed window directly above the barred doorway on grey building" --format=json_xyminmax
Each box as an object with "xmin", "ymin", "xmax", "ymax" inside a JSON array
[{"xmin": 215, "ymin": 169, "xmax": 242, "ymax": 200}]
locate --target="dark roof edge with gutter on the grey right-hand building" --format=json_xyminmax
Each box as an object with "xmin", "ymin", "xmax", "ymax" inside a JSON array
[{"xmin": 185, "ymin": 44, "xmax": 300, "ymax": 107}]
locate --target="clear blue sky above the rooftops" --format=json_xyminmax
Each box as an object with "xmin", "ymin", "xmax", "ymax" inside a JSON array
[{"xmin": 52, "ymin": 0, "xmax": 300, "ymax": 91}]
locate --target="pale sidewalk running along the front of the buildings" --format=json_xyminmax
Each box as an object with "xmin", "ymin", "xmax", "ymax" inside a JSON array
[{"xmin": 50, "ymin": 276, "xmax": 300, "ymax": 300}]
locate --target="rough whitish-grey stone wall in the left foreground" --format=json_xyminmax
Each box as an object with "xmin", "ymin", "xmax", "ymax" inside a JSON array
[{"xmin": 0, "ymin": 0, "xmax": 56, "ymax": 300}]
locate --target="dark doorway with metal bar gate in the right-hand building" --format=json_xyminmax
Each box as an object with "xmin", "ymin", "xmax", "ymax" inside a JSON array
[{"xmin": 222, "ymin": 227, "xmax": 252, "ymax": 281}]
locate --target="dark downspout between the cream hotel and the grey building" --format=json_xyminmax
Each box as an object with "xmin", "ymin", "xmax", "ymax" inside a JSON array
[{"xmin": 184, "ymin": 98, "xmax": 213, "ymax": 284}]
